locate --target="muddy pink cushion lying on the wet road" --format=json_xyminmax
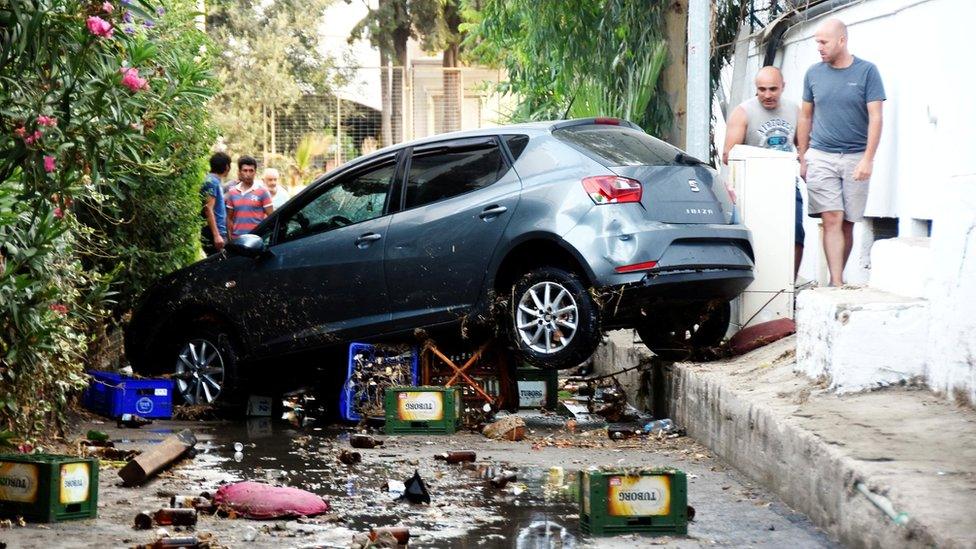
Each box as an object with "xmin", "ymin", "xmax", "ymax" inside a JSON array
[{"xmin": 213, "ymin": 481, "xmax": 331, "ymax": 519}]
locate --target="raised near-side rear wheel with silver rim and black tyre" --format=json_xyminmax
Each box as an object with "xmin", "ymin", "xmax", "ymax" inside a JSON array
[{"xmin": 509, "ymin": 267, "xmax": 600, "ymax": 369}]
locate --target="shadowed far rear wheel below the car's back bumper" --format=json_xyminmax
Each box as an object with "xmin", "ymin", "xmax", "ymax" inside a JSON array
[{"xmin": 636, "ymin": 301, "xmax": 732, "ymax": 360}]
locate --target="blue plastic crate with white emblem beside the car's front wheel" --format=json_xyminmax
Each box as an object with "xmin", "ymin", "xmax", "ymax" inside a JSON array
[{"xmin": 82, "ymin": 371, "xmax": 173, "ymax": 419}]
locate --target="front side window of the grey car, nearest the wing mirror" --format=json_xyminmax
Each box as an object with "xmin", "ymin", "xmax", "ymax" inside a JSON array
[{"xmin": 279, "ymin": 161, "xmax": 396, "ymax": 242}]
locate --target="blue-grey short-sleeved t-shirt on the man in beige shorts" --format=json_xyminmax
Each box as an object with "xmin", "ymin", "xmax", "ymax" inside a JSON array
[{"xmin": 803, "ymin": 57, "xmax": 886, "ymax": 153}]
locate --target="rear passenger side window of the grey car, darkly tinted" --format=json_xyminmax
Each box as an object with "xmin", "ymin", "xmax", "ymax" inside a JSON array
[{"xmin": 405, "ymin": 140, "xmax": 508, "ymax": 209}]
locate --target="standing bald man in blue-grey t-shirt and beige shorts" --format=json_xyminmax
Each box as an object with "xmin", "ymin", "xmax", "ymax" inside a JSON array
[{"xmin": 796, "ymin": 19, "xmax": 885, "ymax": 286}]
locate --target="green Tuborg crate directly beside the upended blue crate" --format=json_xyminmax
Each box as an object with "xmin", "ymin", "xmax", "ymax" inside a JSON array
[{"xmin": 384, "ymin": 387, "xmax": 461, "ymax": 435}]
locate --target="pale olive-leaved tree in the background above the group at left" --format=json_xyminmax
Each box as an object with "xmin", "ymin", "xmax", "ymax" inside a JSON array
[{"xmin": 207, "ymin": 0, "xmax": 343, "ymax": 156}]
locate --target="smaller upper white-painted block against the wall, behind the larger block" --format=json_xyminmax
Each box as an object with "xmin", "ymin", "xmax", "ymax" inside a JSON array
[{"xmin": 869, "ymin": 237, "xmax": 932, "ymax": 298}]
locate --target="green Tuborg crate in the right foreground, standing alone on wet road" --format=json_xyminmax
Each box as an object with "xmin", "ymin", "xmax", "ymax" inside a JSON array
[{"xmin": 579, "ymin": 469, "xmax": 688, "ymax": 536}]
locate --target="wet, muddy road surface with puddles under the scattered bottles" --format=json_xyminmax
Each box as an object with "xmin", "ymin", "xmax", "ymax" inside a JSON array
[{"xmin": 0, "ymin": 418, "xmax": 834, "ymax": 549}]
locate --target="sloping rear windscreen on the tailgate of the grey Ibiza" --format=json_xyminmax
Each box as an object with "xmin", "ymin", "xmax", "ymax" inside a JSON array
[{"xmin": 552, "ymin": 124, "xmax": 681, "ymax": 167}]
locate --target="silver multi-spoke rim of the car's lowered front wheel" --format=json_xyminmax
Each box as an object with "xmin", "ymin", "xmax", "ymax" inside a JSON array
[{"xmin": 173, "ymin": 339, "xmax": 224, "ymax": 404}]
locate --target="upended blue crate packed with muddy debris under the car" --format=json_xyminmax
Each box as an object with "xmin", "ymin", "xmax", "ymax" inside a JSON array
[{"xmin": 339, "ymin": 343, "xmax": 418, "ymax": 421}]
